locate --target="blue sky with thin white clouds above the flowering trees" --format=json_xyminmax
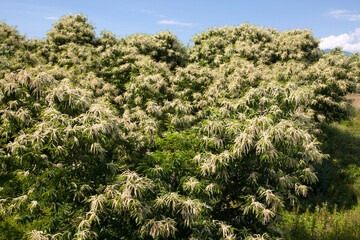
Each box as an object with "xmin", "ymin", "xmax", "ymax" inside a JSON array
[{"xmin": 0, "ymin": 0, "xmax": 360, "ymax": 52}]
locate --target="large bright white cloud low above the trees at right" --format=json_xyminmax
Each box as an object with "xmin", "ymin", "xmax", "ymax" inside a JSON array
[{"xmin": 319, "ymin": 28, "xmax": 360, "ymax": 53}]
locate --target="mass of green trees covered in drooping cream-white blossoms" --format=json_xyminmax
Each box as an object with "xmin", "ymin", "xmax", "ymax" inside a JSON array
[{"xmin": 0, "ymin": 15, "xmax": 359, "ymax": 239}]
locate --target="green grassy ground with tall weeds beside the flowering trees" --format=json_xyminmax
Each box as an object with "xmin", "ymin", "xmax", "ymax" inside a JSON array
[{"xmin": 277, "ymin": 94, "xmax": 360, "ymax": 240}]
